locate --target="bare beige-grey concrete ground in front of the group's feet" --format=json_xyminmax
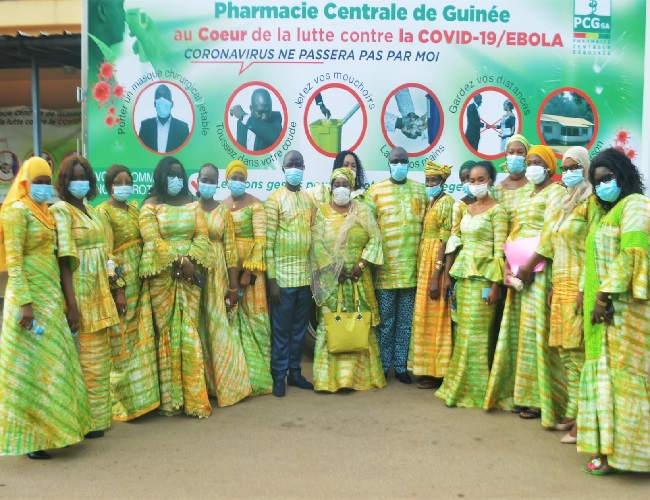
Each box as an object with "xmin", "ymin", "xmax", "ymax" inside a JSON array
[{"xmin": 0, "ymin": 364, "xmax": 650, "ymax": 499}]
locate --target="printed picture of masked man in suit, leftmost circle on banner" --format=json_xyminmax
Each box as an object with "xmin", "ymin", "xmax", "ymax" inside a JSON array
[{"xmin": 138, "ymin": 83, "xmax": 190, "ymax": 154}]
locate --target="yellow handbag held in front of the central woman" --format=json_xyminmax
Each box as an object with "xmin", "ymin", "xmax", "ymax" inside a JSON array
[{"xmin": 323, "ymin": 282, "xmax": 372, "ymax": 354}]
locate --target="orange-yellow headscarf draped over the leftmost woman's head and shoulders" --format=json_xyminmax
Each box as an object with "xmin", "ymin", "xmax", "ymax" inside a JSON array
[{"xmin": 0, "ymin": 156, "xmax": 56, "ymax": 269}]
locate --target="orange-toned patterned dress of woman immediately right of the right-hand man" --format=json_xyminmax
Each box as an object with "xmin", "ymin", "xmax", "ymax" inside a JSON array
[{"xmin": 407, "ymin": 194, "xmax": 454, "ymax": 378}]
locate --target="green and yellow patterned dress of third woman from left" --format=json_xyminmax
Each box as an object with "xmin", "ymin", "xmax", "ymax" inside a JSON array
[{"xmin": 97, "ymin": 202, "xmax": 160, "ymax": 421}]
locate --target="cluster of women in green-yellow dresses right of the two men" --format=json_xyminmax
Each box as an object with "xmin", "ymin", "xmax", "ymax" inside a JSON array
[{"xmin": 411, "ymin": 135, "xmax": 650, "ymax": 475}]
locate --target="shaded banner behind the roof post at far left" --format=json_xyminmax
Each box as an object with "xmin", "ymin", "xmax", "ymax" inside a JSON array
[{"xmin": 0, "ymin": 106, "xmax": 81, "ymax": 203}]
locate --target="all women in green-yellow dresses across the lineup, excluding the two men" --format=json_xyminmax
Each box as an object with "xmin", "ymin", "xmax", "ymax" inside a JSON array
[{"xmin": 0, "ymin": 141, "xmax": 650, "ymax": 474}]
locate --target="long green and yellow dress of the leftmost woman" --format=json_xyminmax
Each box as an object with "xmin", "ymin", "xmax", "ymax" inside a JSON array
[{"xmin": 0, "ymin": 201, "xmax": 94, "ymax": 455}]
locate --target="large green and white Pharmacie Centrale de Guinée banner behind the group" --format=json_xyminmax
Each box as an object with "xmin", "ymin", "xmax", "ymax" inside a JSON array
[{"xmin": 85, "ymin": 0, "xmax": 647, "ymax": 199}]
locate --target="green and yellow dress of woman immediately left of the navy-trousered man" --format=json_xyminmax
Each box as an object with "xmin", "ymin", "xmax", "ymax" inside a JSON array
[{"xmin": 231, "ymin": 201, "xmax": 273, "ymax": 396}]
